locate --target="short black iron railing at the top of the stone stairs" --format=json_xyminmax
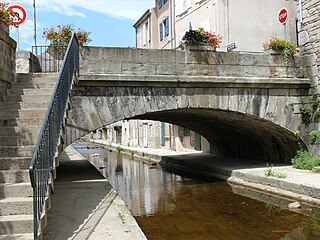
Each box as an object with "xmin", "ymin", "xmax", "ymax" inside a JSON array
[{"xmin": 31, "ymin": 45, "xmax": 68, "ymax": 73}]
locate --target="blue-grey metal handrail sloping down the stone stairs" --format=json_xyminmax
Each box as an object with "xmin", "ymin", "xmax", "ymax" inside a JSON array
[{"xmin": 29, "ymin": 35, "xmax": 79, "ymax": 240}]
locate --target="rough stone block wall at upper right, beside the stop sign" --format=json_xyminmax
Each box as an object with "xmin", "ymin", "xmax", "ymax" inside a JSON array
[{"xmin": 297, "ymin": 0, "xmax": 320, "ymax": 88}]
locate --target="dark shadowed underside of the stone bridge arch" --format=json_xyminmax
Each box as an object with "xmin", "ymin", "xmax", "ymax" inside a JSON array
[{"xmin": 135, "ymin": 108, "xmax": 299, "ymax": 163}]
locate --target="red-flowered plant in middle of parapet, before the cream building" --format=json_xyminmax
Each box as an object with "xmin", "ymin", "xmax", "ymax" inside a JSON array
[{"xmin": 182, "ymin": 28, "xmax": 222, "ymax": 50}]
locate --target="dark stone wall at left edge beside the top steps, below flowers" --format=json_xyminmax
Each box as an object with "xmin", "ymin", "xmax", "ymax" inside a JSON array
[{"xmin": 0, "ymin": 29, "xmax": 17, "ymax": 95}]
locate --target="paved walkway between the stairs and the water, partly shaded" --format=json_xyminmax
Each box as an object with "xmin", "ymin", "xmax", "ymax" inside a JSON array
[{"xmin": 44, "ymin": 147, "xmax": 146, "ymax": 240}]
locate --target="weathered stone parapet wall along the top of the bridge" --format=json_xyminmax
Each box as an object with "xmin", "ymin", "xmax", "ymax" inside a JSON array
[{"xmin": 80, "ymin": 47, "xmax": 306, "ymax": 78}]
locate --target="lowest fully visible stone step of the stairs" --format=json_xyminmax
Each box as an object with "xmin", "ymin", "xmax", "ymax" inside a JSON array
[{"xmin": 0, "ymin": 215, "xmax": 33, "ymax": 235}]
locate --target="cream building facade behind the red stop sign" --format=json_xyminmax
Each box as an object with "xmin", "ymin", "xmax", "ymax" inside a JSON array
[{"xmin": 174, "ymin": 0, "xmax": 297, "ymax": 51}]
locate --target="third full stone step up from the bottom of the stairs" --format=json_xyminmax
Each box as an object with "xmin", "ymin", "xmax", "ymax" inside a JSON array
[{"xmin": 0, "ymin": 182, "xmax": 33, "ymax": 198}]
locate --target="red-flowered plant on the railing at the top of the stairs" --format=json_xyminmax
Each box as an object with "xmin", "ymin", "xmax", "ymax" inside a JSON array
[{"xmin": 43, "ymin": 24, "xmax": 92, "ymax": 60}]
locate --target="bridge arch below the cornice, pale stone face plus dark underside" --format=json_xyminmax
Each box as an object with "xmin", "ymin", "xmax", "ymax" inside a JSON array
[{"xmin": 66, "ymin": 87, "xmax": 306, "ymax": 163}]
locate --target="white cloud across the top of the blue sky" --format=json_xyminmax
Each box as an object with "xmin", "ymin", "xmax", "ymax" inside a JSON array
[{"xmin": 23, "ymin": 0, "xmax": 154, "ymax": 20}]
